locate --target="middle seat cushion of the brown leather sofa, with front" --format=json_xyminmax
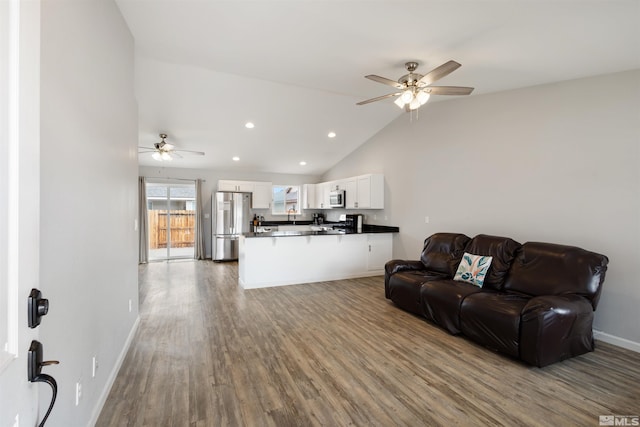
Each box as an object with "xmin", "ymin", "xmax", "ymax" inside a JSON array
[{"xmin": 420, "ymin": 280, "xmax": 482, "ymax": 335}]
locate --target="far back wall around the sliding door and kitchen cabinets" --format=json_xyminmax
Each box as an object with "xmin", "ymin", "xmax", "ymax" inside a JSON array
[{"xmin": 139, "ymin": 166, "xmax": 319, "ymax": 258}]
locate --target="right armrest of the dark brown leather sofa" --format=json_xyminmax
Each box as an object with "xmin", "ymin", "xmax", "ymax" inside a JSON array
[{"xmin": 520, "ymin": 294, "xmax": 594, "ymax": 367}]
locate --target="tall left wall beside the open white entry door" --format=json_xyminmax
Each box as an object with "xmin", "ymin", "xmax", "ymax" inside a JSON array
[{"xmin": 39, "ymin": 0, "xmax": 138, "ymax": 427}]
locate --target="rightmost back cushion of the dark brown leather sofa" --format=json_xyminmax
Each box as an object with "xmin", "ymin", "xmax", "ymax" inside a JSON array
[{"xmin": 504, "ymin": 242, "xmax": 609, "ymax": 310}]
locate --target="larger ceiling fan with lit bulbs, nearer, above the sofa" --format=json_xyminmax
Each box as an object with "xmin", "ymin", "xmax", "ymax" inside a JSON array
[{"xmin": 356, "ymin": 61, "xmax": 473, "ymax": 111}]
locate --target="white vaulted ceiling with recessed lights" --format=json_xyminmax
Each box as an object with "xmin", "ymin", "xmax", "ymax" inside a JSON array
[{"xmin": 117, "ymin": 0, "xmax": 640, "ymax": 175}]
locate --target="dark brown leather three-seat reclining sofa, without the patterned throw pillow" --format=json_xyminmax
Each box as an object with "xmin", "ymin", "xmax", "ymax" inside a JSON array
[{"xmin": 384, "ymin": 233, "xmax": 609, "ymax": 367}]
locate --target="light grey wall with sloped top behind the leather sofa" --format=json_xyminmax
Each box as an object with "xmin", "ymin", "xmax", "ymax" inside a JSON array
[{"xmin": 322, "ymin": 70, "xmax": 640, "ymax": 350}]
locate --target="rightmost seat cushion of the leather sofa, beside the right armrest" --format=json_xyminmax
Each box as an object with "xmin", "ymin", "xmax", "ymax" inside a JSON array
[{"xmin": 460, "ymin": 291, "xmax": 531, "ymax": 357}]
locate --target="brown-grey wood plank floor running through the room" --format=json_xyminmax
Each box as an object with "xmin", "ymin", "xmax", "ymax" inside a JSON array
[{"xmin": 97, "ymin": 261, "xmax": 640, "ymax": 427}]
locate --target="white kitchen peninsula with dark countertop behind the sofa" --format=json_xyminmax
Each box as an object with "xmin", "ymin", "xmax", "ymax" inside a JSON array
[{"xmin": 238, "ymin": 224, "xmax": 399, "ymax": 289}]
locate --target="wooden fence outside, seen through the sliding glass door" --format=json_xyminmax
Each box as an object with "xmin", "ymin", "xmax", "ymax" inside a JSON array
[{"xmin": 149, "ymin": 210, "xmax": 196, "ymax": 249}]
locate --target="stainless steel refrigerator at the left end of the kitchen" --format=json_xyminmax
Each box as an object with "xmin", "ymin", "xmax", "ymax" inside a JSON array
[{"xmin": 211, "ymin": 191, "xmax": 251, "ymax": 261}]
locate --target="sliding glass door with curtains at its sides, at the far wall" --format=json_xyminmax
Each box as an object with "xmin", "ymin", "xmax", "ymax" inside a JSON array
[{"xmin": 147, "ymin": 182, "xmax": 196, "ymax": 261}]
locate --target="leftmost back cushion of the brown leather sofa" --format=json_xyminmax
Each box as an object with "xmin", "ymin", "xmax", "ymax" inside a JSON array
[{"xmin": 420, "ymin": 233, "xmax": 470, "ymax": 277}]
